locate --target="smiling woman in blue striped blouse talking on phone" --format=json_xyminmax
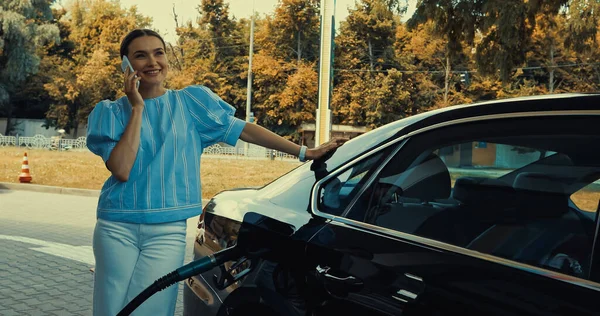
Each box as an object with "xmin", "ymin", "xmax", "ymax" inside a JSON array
[{"xmin": 87, "ymin": 29, "xmax": 345, "ymax": 316}]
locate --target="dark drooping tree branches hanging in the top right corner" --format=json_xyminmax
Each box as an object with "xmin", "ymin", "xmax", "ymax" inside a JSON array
[{"xmin": 410, "ymin": 0, "xmax": 600, "ymax": 86}]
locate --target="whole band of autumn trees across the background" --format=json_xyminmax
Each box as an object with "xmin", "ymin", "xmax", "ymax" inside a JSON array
[{"xmin": 0, "ymin": 0, "xmax": 600, "ymax": 140}]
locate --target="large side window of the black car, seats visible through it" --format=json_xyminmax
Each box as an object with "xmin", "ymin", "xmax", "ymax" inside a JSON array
[{"xmin": 346, "ymin": 136, "xmax": 600, "ymax": 278}]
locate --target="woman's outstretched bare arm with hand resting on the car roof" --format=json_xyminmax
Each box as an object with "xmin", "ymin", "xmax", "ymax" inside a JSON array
[{"xmin": 240, "ymin": 123, "xmax": 347, "ymax": 160}]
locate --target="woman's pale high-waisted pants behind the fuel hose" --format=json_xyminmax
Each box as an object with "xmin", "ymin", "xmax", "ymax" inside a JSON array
[{"xmin": 93, "ymin": 219, "xmax": 187, "ymax": 316}]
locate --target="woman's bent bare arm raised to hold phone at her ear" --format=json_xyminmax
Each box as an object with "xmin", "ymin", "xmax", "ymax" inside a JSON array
[{"xmin": 106, "ymin": 69, "xmax": 144, "ymax": 182}]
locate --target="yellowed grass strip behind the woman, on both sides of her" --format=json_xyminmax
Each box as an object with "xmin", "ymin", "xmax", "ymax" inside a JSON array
[{"xmin": 0, "ymin": 147, "xmax": 298, "ymax": 198}]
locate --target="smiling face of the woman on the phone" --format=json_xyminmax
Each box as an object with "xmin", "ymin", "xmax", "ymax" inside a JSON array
[{"xmin": 127, "ymin": 36, "xmax": 169, "ymax": 86}]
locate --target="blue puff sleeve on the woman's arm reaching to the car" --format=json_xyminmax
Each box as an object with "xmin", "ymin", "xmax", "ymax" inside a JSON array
[{"xmin": 183, "ymin": 85, "xmax": 246, "ymax": 148}]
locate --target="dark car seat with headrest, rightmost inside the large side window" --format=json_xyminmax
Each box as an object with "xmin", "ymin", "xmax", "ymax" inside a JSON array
[{"xmin": 466, "ymin": 172, "xmax": 591, "ymax": 275}]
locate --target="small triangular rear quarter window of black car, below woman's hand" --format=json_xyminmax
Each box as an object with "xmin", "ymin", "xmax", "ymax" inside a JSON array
[{"xmin": 318, "ymin": 151, "xmax": 384, "ymax": 216}]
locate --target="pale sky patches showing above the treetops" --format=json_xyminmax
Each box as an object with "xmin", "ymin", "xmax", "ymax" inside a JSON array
[{"xmin": 96, "ymin": 0, "xmax": 416, "ymax": 43}]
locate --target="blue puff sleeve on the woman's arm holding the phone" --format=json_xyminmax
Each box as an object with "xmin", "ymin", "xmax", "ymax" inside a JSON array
[{"xmin": 86, "ymin": 100, "xmax": 125, "ymax": 163}]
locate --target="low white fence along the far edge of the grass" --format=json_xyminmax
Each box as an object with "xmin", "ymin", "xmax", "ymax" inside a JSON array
[{"xmin": 0, "ymin": 134, "xmax": 297, "ymax": 161}]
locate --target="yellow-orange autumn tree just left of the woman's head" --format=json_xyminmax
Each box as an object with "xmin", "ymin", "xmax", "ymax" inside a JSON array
[{"xmin": 44, "ymin": 0, "xmax": 151, "ymax": 135}]
